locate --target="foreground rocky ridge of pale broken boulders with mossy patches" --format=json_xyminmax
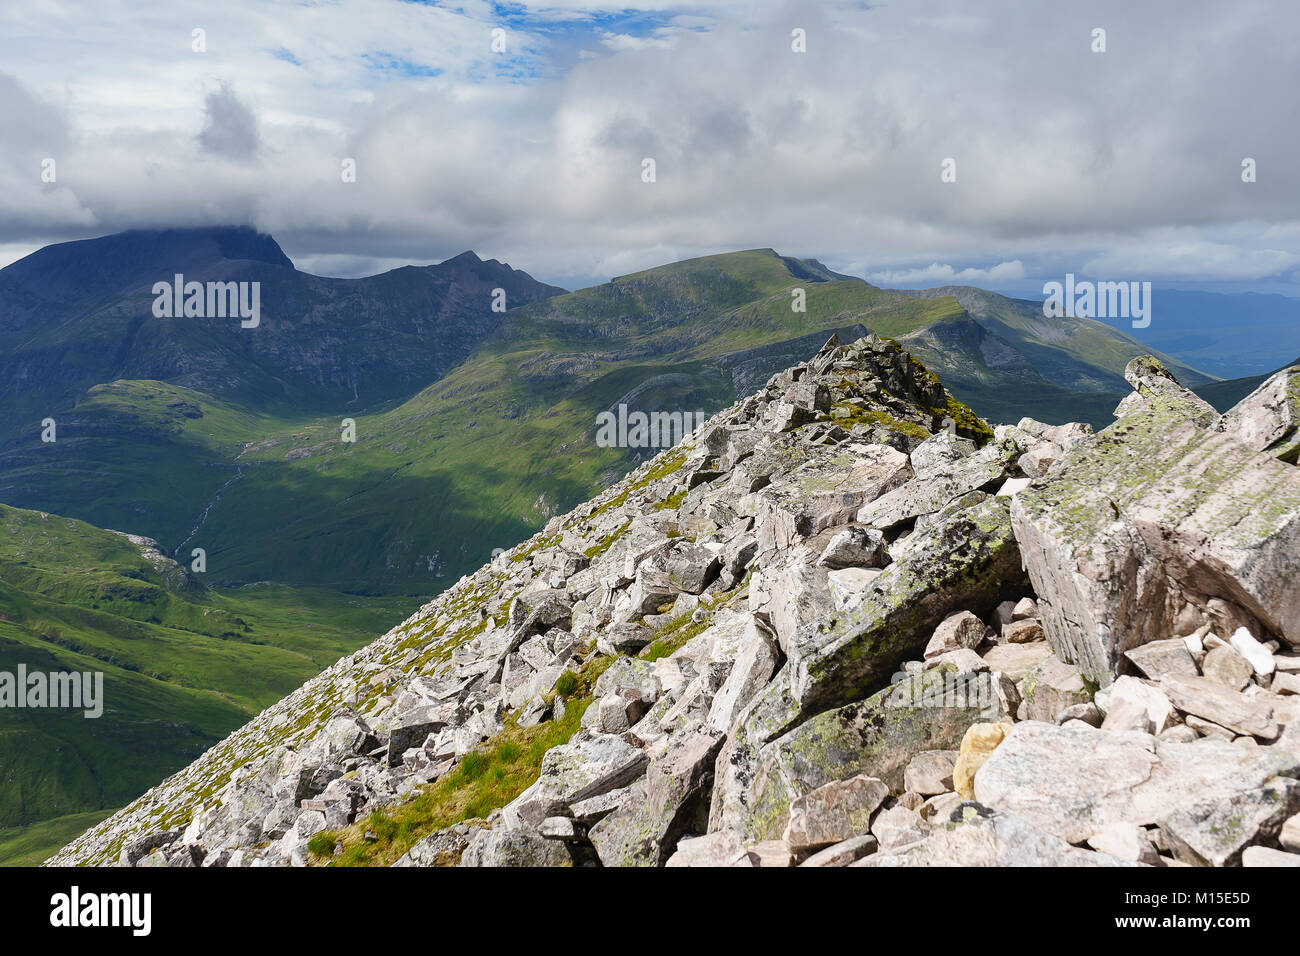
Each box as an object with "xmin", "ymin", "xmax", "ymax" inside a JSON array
[{"xmin": 49, "ymin": 337, "xmax": 1300, "ymax": 866}]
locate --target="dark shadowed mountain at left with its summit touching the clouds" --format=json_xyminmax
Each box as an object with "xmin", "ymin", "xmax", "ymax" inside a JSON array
[{"xmin": 0, "ymin": 228, "xmax": 563, "ymax": 432}]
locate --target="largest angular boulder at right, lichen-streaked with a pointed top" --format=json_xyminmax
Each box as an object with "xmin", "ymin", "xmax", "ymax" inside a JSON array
[{"xmin": 1011, "ymin": 359, "xmax": 1300, "ymax": 684}]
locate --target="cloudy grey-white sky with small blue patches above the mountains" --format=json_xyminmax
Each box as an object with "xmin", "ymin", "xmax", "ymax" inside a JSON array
[{"xmin": 0, "ymin": 0, "xmax": 1300, "ymax": 295}]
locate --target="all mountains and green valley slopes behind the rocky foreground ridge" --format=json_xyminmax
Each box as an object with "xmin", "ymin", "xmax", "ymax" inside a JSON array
[{"xmin": 0, "ymin": 228, "xmax": 1279, "ymax": 856}]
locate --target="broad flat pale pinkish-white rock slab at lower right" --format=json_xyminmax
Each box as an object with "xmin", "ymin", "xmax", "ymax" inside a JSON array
[{"xmin": 975, "ymin": 721, "xmax": 1300, "ymax": 843}]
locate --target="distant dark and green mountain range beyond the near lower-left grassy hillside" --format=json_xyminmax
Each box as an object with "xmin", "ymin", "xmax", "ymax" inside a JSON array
[{"xmin": 0, "ymin": 229, "xmax": 1232, "ymax": 594}]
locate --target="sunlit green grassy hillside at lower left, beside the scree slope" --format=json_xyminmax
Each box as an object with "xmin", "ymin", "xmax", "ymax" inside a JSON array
[{"xmin": 0, "ymin": 506, "xmax": 412, "ymax": 842}]
